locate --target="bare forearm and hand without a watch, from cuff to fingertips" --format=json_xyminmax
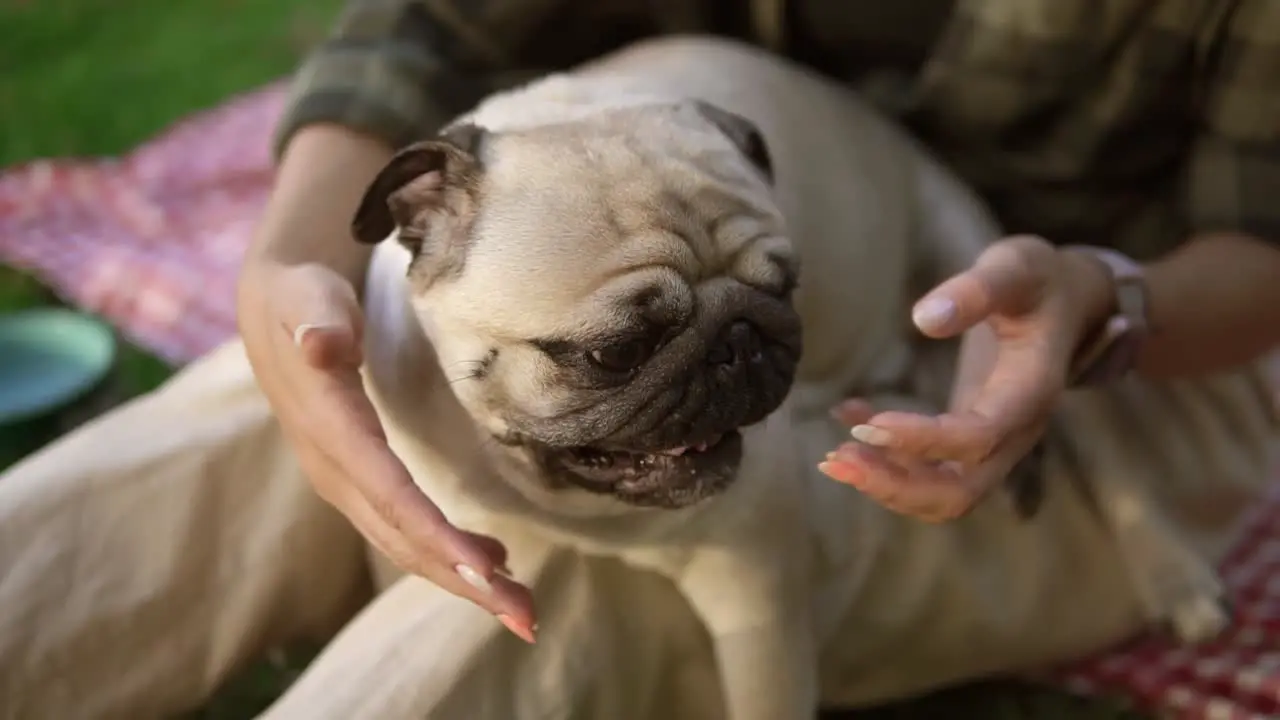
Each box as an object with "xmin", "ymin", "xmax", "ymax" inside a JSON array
[{"xmin": 237, "ymin": 126, "xmax": 534, "ymax": 642}]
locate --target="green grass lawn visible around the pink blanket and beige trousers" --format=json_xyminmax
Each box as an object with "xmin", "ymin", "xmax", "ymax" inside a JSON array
[{"xmin": 0, "ymin": 0, "xmax": 1135, "ymax": 720}]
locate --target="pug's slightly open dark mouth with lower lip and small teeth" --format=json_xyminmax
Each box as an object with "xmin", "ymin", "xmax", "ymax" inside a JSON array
[{"xmin": 552, "ymin": 430, "xmax": 742, "ymax": 509}]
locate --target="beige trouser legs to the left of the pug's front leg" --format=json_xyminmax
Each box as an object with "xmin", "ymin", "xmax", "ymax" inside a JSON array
[{"xmin": 0, "ymin": 342, "xmax": 719, "ymax": 720}]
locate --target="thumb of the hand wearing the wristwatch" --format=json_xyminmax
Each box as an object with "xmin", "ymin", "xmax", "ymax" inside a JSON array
[{"xmin": 911, "ymin": 236, "xmax": 1055, "ymax": 338}]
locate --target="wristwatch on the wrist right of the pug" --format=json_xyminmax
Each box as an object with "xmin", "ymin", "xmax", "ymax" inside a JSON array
[{"xmin": 1064, "ymin": 245, "xmax": 1151, "ymax": 387}]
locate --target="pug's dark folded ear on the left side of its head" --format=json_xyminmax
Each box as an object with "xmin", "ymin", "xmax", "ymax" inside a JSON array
[{"xmin": 351, "ymin": 124, "xmax": 486, "ymax": 248}]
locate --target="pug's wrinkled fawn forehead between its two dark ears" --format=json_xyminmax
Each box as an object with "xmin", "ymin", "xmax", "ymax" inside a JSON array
[{"xmin": 463, "ymin": 108, "xmax": 782, "ymax": 322}]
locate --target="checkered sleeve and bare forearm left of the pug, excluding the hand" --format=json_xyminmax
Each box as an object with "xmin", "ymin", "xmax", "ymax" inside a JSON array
[{"xmin": 242, "ymin": 0, "xmax": 517, "ymax": 292}]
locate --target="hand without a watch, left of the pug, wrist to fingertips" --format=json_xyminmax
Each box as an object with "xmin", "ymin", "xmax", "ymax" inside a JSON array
[{"xmin": 239, "ymin": 258, "xmax": 534, "ymax": 642}]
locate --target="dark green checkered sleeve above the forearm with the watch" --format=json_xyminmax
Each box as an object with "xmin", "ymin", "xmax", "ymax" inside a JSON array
[{"xmin": 1187, "ymin": 0, "xmax": 1280, "ymax": 243}]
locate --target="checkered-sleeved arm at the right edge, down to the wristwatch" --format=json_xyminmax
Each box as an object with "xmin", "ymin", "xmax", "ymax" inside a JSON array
[{"xmin": 1137, "ymin": 0, "xmax": 1280, "ymax": 377}]
